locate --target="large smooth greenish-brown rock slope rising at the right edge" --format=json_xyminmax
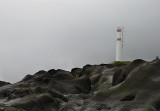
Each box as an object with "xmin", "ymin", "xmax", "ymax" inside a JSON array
[{"xmin": 93, "ymin": 60, "xmax": 160, "ymax": 111}]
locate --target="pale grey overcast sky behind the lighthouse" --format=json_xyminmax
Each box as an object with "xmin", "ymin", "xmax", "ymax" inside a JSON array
[{"xmin": 0, "ymin": 0, "xmax": 160, "ymax": 83}]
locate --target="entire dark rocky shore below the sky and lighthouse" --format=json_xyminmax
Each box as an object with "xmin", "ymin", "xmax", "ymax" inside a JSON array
[{"xmin": 0, "ymin": 59, "xmax": 160, "ymax": 111}]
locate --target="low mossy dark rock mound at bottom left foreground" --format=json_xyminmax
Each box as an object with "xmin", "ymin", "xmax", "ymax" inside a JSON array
[{"xmin": 10, "ymin": 93, "xmax": 58, "ymax": 111}]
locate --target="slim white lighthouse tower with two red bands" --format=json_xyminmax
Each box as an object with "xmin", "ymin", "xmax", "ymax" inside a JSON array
[{"xmin": 116, "ymin": 27, "xmax": 123, "ymax": 61}]
